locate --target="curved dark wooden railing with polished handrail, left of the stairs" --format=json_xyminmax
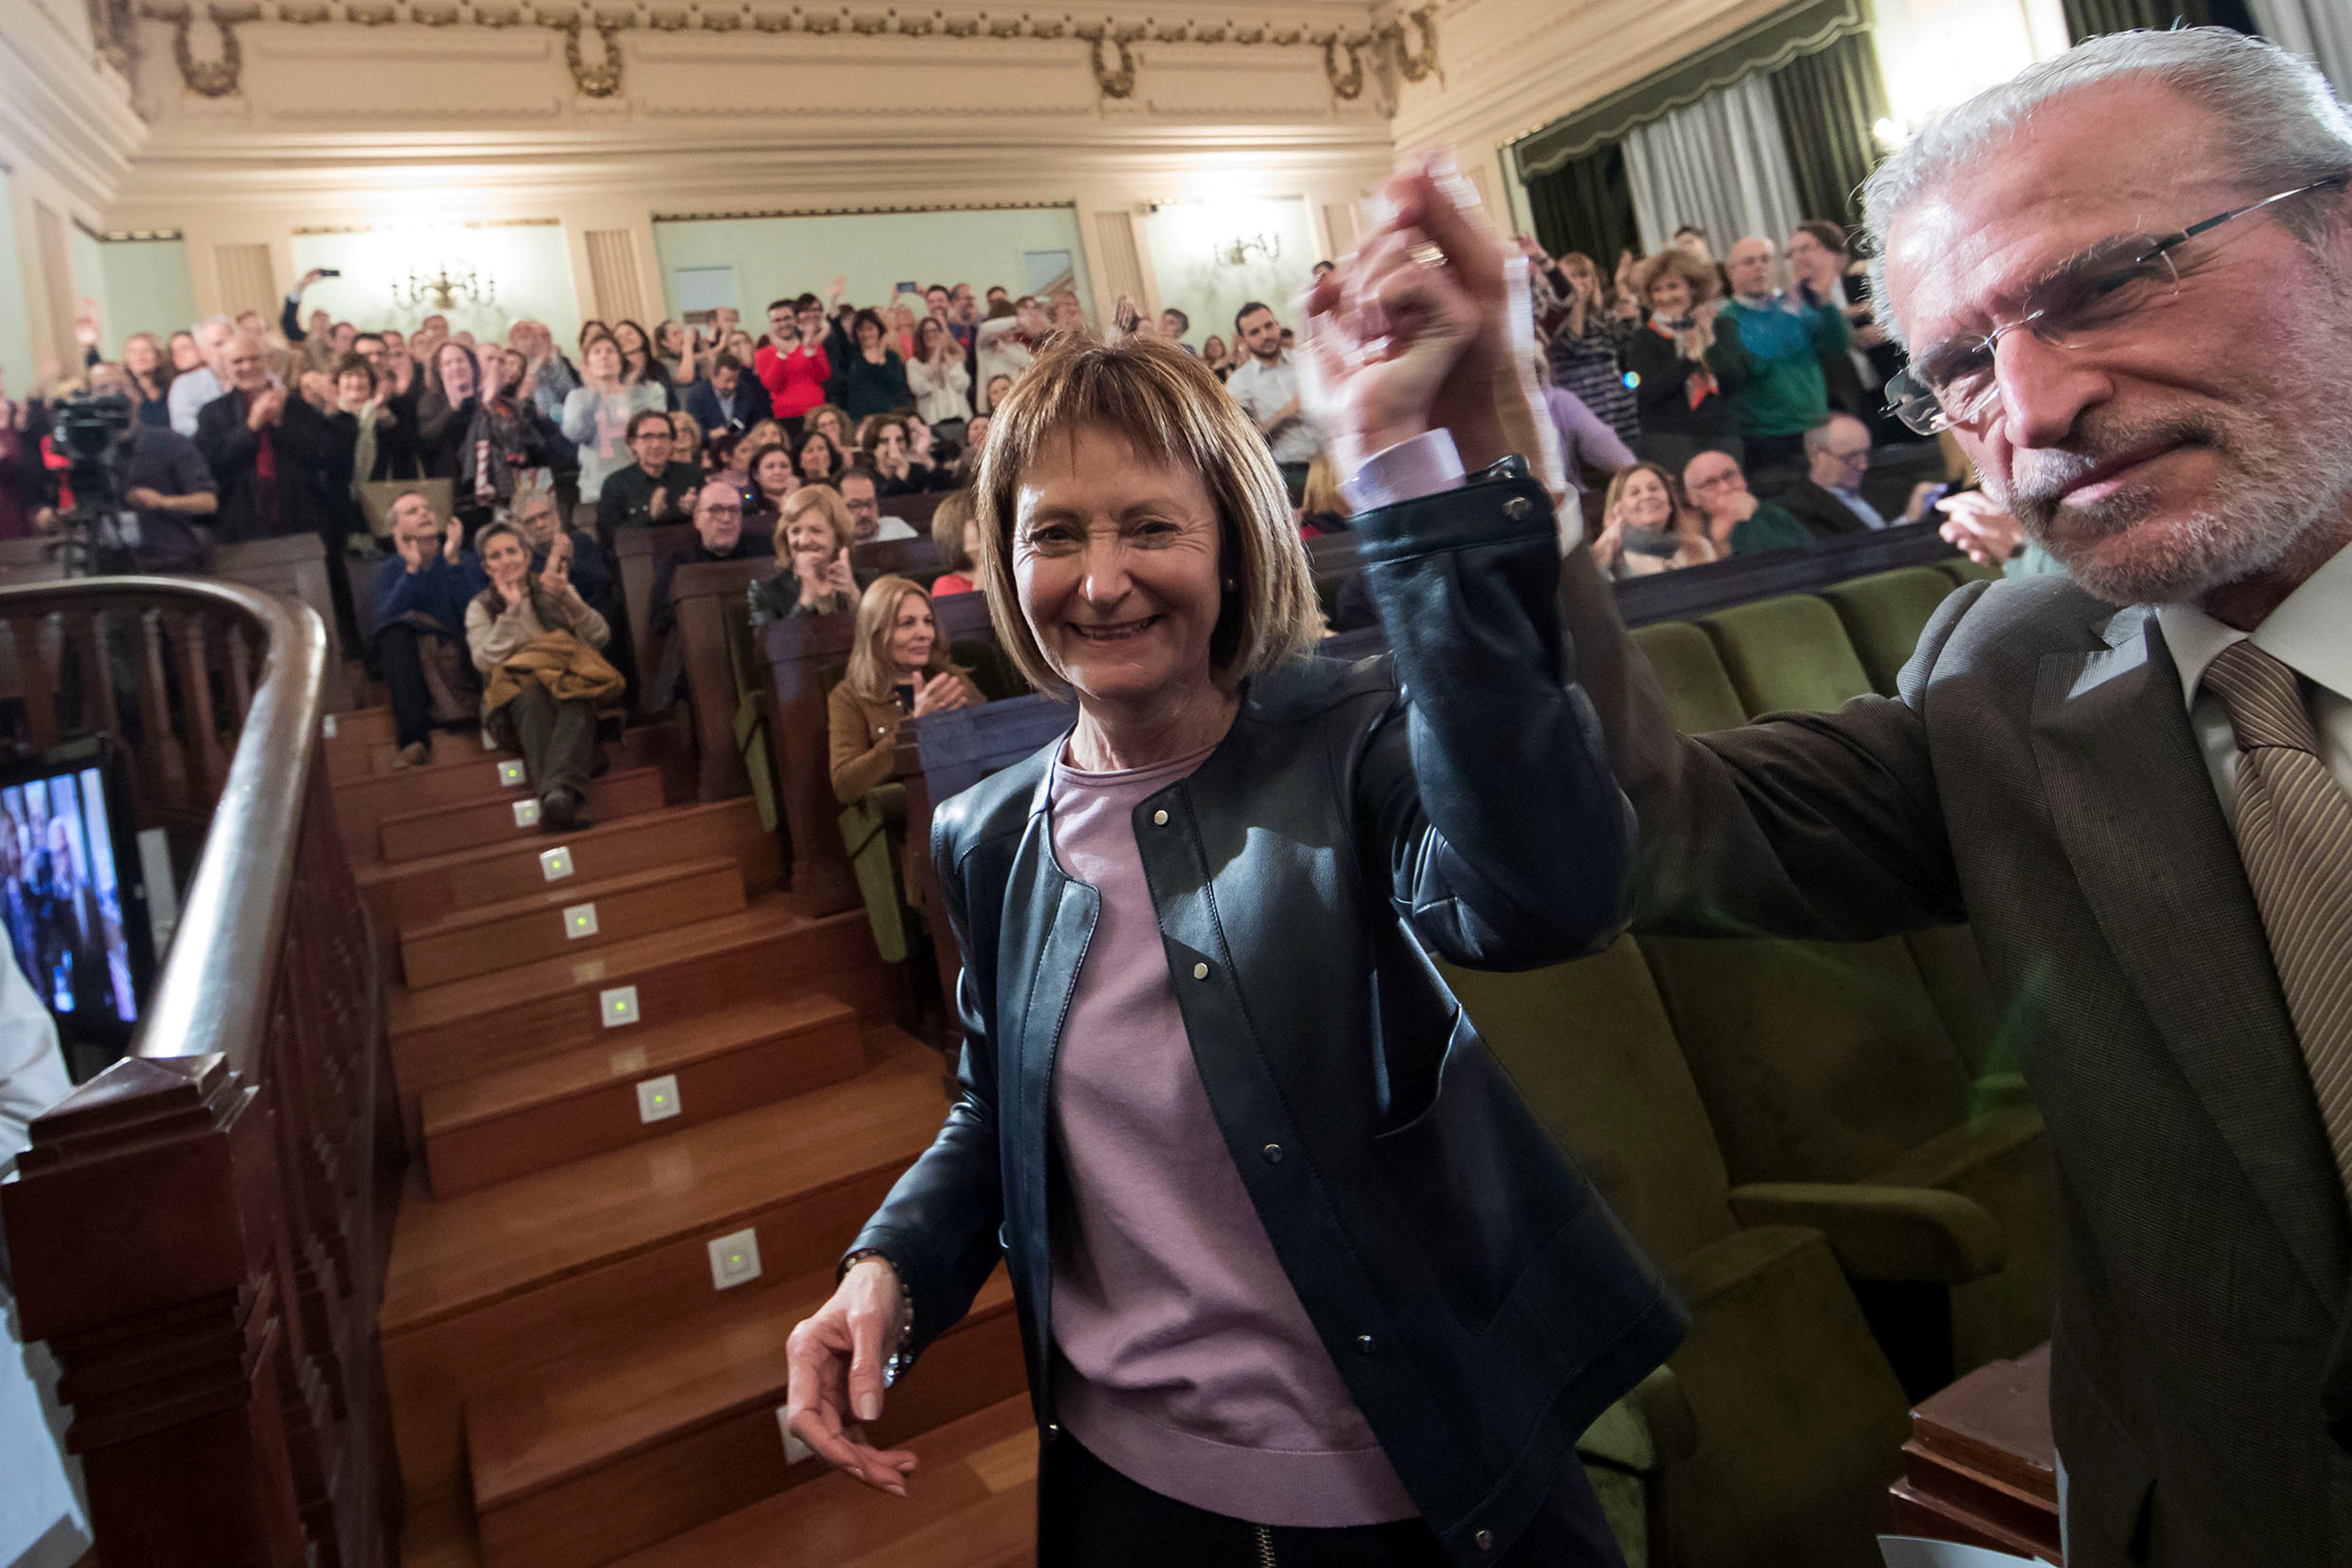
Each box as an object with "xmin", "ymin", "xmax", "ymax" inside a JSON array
[{"xmin": 0, "ymin": 578, "xmax": 400, "ymax": 1568}]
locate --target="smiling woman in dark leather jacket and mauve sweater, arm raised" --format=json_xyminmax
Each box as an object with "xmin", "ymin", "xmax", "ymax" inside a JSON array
[{"xmin": 786, "ymin": 174, "xmax": 1679, "ymax": 1568}]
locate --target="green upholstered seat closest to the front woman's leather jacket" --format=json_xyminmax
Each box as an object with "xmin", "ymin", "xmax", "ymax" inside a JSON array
[{"xmin": 1446, "ymin": 940, "xmax": 1919, "ymax": 1568}]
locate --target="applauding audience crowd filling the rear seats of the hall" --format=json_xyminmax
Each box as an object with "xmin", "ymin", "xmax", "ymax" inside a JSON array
[{"xmin": 0, "ymin": 224, "xmax": 1940, "ymax": 823}]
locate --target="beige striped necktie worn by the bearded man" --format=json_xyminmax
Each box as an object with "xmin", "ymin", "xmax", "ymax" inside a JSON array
[{"xmin": 2204, "ymin": 642, "xmax": 2352, "ymax": 1187}]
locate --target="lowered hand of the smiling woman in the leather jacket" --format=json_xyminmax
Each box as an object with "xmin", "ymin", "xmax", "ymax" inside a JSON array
[{"xmin": 783, "ymin": 1257, "xmax": 915, "ymax": 1498}]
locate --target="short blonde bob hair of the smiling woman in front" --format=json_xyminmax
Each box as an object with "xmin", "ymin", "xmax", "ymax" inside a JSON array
[{"xmin": 971, "ymin": 334, "xmax": 1322, "ymax": 698}]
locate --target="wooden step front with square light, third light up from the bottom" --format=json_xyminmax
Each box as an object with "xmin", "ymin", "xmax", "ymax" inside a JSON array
[{"xmin": 421, "ymin": 997, "xmax": 865, "ymax": 1199}]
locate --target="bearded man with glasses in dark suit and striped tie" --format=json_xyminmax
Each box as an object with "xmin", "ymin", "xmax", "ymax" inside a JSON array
[{"xmin": 1515, "ymin": 28, "xmax": 2352, "ymax": 1568}]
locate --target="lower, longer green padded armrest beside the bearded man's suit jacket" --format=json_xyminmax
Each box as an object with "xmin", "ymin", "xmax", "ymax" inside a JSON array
[{"xmin": 1731, "ymin": 1183, "xmax": 2008, "ymax": 1286}]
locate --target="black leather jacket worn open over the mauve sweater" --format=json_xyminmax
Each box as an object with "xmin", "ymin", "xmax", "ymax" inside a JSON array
[{"xmin": 854, "ymin": 475, "xmax": 1681, "ymax": 1563}]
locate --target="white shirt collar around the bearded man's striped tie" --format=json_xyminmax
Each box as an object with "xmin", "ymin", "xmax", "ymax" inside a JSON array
[{"xmin": 2157, "ymin": 536, "xmax": 2352, "ymax": 830}]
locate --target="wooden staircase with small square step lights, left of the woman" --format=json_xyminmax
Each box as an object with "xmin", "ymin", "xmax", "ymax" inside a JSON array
[{"xmin": 327, "ymin": 710, "xmax": 1037, "ymax": 1568}]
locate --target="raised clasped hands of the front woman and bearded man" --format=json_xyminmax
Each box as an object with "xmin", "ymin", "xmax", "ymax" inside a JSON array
[{"xmin": 1300, "ymin": 167, "xmax": 1510, "ymax": 477}]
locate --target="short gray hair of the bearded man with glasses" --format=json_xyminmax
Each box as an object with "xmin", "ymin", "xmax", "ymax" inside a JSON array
[{"xmin": 1863, "ymin": 28, "xmax": 2352, "ymax": 341}]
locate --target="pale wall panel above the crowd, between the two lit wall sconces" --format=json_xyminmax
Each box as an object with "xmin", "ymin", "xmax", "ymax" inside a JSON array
[{"xmin": 647, "ymin": 207, "xmax": 1093, "ymax": 334}]
